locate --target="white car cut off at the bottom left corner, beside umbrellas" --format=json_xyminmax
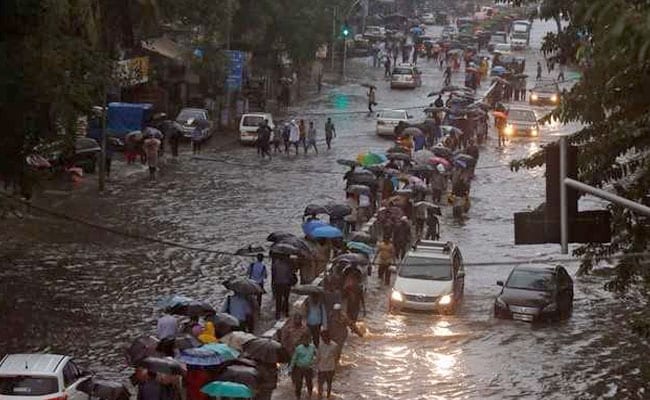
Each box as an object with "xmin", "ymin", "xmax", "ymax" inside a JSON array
[{"xmin": 0, "ymin": 354, "xmax": 92, "ymax": 400}]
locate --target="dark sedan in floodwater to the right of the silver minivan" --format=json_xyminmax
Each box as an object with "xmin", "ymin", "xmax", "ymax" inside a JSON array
[{"xmin": 494, "ymin": 265, "xmax": 573, "ymax": 322}]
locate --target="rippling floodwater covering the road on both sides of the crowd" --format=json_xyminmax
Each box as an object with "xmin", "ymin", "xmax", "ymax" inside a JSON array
[{"xmin": 0, "ymin": 21, "xmax": 650, "ymax": 400}]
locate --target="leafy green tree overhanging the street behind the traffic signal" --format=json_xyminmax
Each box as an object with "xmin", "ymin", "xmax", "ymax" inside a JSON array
[{"xmin": 512, "ymin": 0, "xmax": 650, "ymax": 334}]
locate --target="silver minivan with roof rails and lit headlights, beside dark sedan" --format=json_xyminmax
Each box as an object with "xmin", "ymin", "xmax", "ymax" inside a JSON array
[{"xmin": 389, "ymin": 240, "xmax": 465, "ymax": 314}]
